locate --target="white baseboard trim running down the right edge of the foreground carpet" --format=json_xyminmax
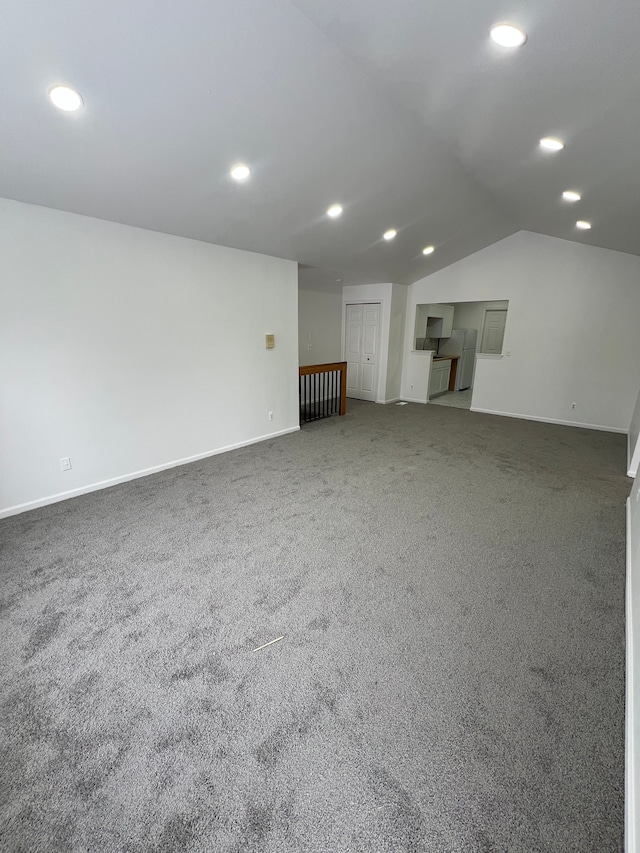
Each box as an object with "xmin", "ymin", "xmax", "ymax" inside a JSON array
[{"xmin": 624, "ymin": 498, "xmax": 640, "ymax": 853}]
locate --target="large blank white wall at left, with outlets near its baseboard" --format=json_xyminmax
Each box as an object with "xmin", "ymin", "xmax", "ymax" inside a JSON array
[{"xmin": 0, "ymin": 200, "xmax": 298, "ymax": 515}]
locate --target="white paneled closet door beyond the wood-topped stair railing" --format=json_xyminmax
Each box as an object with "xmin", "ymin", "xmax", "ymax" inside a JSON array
[{"xmin": 344, "ymin": 303, "xmax": 380, "ymax": 401}]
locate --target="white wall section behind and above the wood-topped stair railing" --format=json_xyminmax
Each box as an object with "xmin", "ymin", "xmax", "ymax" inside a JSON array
[{"xmin": 298, "ymin": 287, "xmax": 342, "ymax": 365}]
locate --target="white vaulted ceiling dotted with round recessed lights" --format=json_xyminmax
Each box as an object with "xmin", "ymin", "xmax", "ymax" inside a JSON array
[{"xmin": 0, "ymin": 0, "xmax": 640, "ymax": 283}]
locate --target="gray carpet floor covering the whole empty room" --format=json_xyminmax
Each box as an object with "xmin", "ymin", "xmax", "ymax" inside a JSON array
[{"xmin": 0, "ymin": 401, "xmax": 630, "ymax": 853}]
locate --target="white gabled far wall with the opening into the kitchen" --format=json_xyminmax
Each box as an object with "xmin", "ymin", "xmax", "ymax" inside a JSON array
[{"xmin": 404, "ymin": 231, "xmax": 640, "ymax": 432}]
